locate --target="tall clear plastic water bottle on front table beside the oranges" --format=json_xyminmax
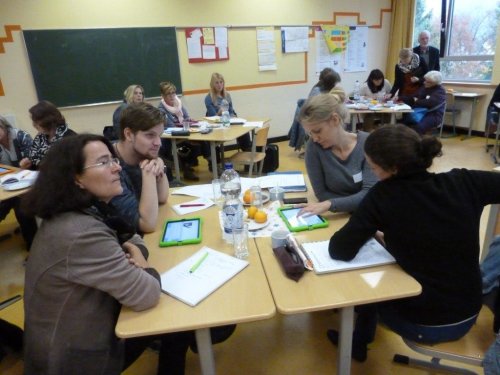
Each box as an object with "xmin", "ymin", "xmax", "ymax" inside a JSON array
[{"xmin": 220, "ymin": 163, "xmax": 243, "ymax": 243}]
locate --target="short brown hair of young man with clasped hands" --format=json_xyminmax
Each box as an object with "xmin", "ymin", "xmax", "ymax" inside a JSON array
[{"xmin": 120, "ymin": 102, "xmax": 165, "ymax": 141}]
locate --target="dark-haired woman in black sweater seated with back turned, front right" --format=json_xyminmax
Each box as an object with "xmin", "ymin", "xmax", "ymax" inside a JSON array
[{"xmin": 328, "ymin": 125, "xmax": 500, "ymax": 361}]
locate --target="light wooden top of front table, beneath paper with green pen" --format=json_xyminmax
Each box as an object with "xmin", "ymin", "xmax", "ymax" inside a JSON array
[{"xmin": 116, "ymin": 195, "xmax": 276, "ymax": 338}]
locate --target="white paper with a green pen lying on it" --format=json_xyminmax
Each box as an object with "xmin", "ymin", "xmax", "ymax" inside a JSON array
[{"xmin": 161, "ymin": 246, "xmax": 248, "ymax": 306}]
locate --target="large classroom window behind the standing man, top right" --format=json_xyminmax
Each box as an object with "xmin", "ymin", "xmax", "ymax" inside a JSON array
[{"xmin": 413, "ymin": 0, "xmax": 500, "ymax": 82}]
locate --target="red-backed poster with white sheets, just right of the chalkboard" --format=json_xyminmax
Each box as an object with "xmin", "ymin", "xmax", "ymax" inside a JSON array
[{"xmin": 185, "ymin": 27, "xmax": 229, "ymax": 63}]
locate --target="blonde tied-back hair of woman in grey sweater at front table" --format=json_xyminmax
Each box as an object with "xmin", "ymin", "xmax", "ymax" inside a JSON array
[{"xmin": 299, "ymin": 93, "xmax": 349, "ymax": 128}]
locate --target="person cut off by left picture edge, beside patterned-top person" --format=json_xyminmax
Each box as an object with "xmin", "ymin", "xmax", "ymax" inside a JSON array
[{"xmin": 0, "ymin": 116, "xmax": 37, "ymax": 251}]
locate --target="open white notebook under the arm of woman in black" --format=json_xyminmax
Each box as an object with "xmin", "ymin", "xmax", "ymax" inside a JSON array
[{"xmin": 302, "ymin": 238, "xmax": 396, "ymax": 274}]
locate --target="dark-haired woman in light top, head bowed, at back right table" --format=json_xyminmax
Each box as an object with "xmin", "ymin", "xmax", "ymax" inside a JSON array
[{"xmin": 359, "ymin": 69, "xmax": 392, "ymax": 131}]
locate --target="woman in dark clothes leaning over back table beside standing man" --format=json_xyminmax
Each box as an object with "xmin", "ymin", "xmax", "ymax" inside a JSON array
[{"xmin": 390, "ymin": 48, "xmax": 429, "ymax": 100}]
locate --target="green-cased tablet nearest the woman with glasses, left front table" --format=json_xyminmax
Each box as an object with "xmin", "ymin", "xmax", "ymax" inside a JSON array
[{"xmin": 160, "ymin": 217, "xmax": 202, "ymax": 247}]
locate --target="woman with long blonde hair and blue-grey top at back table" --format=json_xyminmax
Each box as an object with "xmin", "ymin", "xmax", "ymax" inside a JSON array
[{"xmin": 205, "ymin": 73, "xmax": 252, "ymax": 151}]
